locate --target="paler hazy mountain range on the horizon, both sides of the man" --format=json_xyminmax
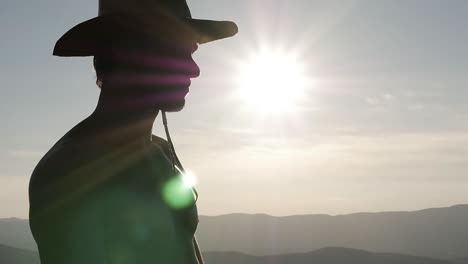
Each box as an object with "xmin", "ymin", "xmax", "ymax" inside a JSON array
[{"xmin": 0, "ymin": 205, "xmax": 468, "ymax": 258}]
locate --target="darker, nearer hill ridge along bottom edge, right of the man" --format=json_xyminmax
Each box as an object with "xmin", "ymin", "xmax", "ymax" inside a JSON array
[{"xmin": 203, "ymin": 248, "xmax": 453, "ymax": 264}]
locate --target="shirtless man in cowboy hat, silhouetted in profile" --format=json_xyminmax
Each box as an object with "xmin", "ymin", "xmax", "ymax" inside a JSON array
[{"xmin": 29, "ymin": 0, "xmax": 237, "ymax": 264}]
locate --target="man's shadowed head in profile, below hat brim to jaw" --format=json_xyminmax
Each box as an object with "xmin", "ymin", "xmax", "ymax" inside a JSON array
[{"xmin": 98, "ymin": 32, "xmax": 200, "ymax": 111}]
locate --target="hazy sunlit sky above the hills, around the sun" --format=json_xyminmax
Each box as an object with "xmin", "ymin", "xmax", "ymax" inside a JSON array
[{"xmin": 0, "ymin": 0, "xmax": 468, "ymax": 218}]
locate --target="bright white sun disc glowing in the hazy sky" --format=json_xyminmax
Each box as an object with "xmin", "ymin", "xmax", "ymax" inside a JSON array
[{"xmin": 237, "ymin": 49, "xmax": 310, "ymax": 113}]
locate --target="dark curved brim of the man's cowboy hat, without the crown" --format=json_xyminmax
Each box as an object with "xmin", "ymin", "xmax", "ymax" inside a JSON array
[{"xmin": 53, "ymin": 15, "xmax": 238, "ymax": 57}]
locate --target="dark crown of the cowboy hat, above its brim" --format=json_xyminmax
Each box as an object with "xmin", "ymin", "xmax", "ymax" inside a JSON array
[{"xmin": 99, "ymin": 0, "xmax": 192, "ymax": 18}]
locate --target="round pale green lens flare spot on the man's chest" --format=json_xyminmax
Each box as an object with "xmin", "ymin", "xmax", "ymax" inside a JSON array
[{"xmin": 162, "ymin": 176, "xmax": 194, "ymax": 209}]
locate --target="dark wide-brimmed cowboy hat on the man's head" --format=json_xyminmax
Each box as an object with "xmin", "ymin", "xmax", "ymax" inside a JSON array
[{"xmin": 53, "ymin": 0, "xmax": 238, "ymax": 57}]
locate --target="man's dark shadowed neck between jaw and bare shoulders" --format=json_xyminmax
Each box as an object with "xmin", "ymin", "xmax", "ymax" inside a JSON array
[{"xmin": 91, "ymin": 88, "xmax": 159, "ymax": 142}]
